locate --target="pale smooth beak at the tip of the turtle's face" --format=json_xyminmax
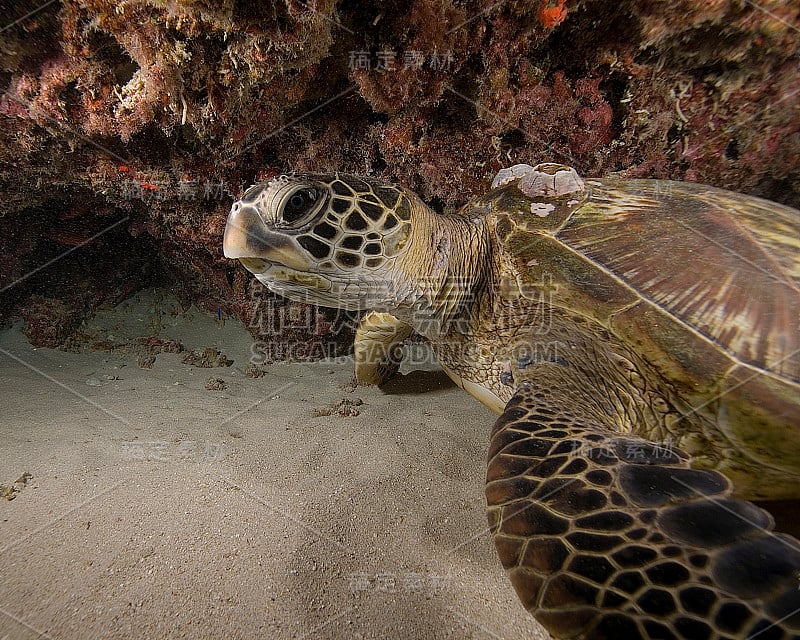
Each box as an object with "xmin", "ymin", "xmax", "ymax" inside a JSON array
[{"xmin": 222, "ymin": 201, "xmax": 312, "ymax": 273}]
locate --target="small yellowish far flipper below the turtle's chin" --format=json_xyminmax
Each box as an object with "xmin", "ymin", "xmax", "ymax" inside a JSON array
[{"xmin": 354, "ymin": 311, "xmax": 412, "ymax": 385}]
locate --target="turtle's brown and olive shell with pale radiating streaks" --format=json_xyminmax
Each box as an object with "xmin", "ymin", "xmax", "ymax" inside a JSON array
[{"xmin": 485, "ymin": 172, "xmax": 800, "ymax": 493}]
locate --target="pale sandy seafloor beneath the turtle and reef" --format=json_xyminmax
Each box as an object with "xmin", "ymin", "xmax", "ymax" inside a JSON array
[{"xmin": 0, "ymin": 291, "xmax": 546, "ymax": 640}]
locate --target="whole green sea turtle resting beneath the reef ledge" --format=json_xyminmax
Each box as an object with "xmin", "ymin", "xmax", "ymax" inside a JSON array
[{"xmin": 224, "ymin": 163, "xmax": 800, "ymax": 640}]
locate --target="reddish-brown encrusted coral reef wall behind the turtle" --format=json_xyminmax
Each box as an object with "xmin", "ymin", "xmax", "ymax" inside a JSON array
[{"xmin": 0, "ymin": 0, "xmax": 800, "ymax": 350}]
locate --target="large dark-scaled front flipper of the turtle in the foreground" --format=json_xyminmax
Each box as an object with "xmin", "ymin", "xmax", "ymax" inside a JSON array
[{"xmin": 486, "ymin": 376, "xmax": 800, "ymax": 640}]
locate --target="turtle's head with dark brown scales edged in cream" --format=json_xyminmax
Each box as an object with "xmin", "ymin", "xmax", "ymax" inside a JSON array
[{"xmin": 223, "ymin": 173, "xmax": 416, "ymax": 310}]
